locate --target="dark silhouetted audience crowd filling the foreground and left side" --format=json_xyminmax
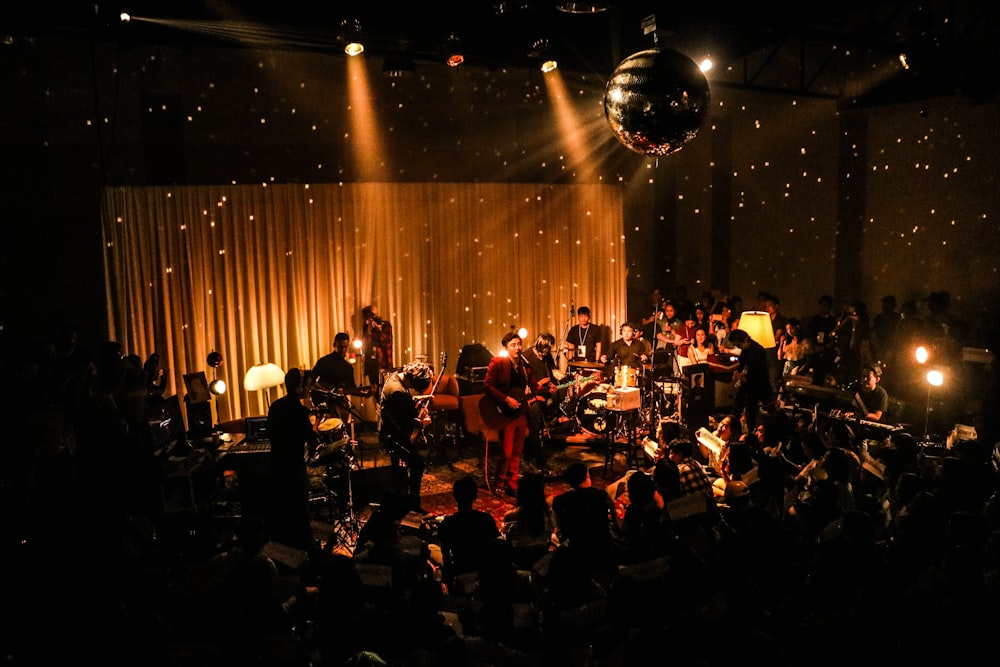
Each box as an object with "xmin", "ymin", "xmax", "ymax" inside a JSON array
[{"xmin": 0, "ymin": 298, "xmax": 1000, "ymax": 667}]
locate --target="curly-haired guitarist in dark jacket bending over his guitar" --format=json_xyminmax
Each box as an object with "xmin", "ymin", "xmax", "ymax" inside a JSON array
[{"xmin": 378, "ymin": 361, "xmax": 434, "ymax": 514}]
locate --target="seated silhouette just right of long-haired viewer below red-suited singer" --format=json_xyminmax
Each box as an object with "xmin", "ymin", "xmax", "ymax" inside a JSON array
[{"xmin": 552, "ymin": 461, "xmax": 620, "ymax": 568}]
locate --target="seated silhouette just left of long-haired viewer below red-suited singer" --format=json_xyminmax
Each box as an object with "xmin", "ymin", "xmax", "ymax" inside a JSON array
[{"xmin": 437, "ymin": 475, "xmax": 501, "ymax": 585}]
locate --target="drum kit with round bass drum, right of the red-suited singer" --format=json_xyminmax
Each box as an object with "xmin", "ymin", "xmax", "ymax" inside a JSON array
[{"xmin": 560, "ymin": 361, "xmax": 682, "ymax": 437}]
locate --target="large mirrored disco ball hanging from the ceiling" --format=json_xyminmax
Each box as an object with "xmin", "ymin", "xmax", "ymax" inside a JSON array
[{"xmin": 604, "ymin": 49, "xmax": 709, "ymax": 156}]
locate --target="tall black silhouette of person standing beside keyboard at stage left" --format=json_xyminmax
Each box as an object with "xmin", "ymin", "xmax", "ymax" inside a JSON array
[{"xmin": 265, "ymin": 368, "xmax": 317, "ymax": 551}]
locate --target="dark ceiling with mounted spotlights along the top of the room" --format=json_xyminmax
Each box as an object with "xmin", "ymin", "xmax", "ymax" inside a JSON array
[{"xmin": 7, "ymin": 0, "xmax": 1000, "ymax": 106}]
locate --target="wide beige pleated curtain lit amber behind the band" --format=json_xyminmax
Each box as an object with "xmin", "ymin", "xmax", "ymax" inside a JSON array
[{"xmin": 103, "ymin": 183, "xmax": 626, "ymax": 421}]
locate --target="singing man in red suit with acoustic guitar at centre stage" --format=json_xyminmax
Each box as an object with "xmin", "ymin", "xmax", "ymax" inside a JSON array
[{"xmin": 483, "ymin": 331, "xmax": 534, "ymax": 497}]
